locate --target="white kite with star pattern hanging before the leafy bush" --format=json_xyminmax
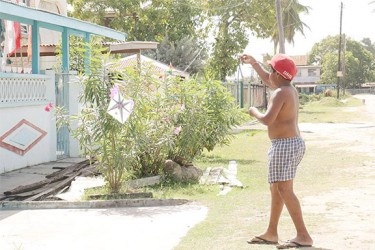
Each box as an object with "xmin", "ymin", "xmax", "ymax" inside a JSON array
[{"xmin": 107, "ymin": 87, "xmax": 134, "ymax": 124}]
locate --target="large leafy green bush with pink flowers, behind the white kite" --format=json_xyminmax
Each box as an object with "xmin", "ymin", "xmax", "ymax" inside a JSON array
[{"xmin": 55, "ymin": 41, "xmax": 244, "ymax": 193}]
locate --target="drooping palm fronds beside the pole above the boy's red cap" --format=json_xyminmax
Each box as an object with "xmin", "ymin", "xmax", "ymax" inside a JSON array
[{"xmin": 272, "ymin": 0, "xmax": 312, "ymax": 54}]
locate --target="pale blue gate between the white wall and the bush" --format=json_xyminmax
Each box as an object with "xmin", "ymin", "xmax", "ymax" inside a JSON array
[{"xmin": 55, "ymin": 73, "xmax": 69, "ymax": 159}]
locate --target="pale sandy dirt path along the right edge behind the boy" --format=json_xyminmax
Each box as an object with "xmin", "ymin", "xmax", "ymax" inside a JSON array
[{"xmin": 300, "ymin": 95, "xmax": 375, "ymax": 250}]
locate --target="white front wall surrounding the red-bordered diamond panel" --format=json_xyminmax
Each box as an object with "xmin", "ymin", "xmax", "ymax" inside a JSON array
[{"xmin": 0, "ymin": 72, "xmax": 56, "ymax": 173}]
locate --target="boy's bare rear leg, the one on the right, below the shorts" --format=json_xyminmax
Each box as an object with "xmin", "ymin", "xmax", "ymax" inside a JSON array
[{"xmin": 277, "ymin": 180, "xmax": 313, "ymax": 245}]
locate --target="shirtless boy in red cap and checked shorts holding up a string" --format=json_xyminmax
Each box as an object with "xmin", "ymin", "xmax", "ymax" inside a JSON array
[{"xmin": 240, "ymin": 54, "xmax": 313, "ymax": 249}]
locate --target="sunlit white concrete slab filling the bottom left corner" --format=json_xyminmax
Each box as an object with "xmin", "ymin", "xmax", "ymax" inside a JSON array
[{"xmin": 0, "ymin": 204, "xmax": 208, "ymax": 250}]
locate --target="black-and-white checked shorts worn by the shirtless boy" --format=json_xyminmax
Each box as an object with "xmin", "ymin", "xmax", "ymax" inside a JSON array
[{"xmin": 268, "ymin": 137, "xmax": 306, "ymax": 183}]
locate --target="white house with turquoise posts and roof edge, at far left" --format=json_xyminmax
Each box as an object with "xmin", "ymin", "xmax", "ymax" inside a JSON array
[{"xmin": 0, "ymin": 0, "xmax": 126, "ymax": 173}]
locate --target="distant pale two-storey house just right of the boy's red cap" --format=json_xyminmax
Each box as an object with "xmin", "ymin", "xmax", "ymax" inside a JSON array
[{"xmin": 291, "ymin": 55, "xmax": 320, "ymax": 94}]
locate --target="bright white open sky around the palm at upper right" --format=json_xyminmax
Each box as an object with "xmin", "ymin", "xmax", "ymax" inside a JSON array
[{"xmin": 244, "ymin": 0, "xmax": 375, "ymax": 60}]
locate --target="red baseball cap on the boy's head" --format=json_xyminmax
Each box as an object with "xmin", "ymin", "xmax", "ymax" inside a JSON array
[{"xmin": 268, "ymin": 54, "xmax": 298, "ymax": 81}]
